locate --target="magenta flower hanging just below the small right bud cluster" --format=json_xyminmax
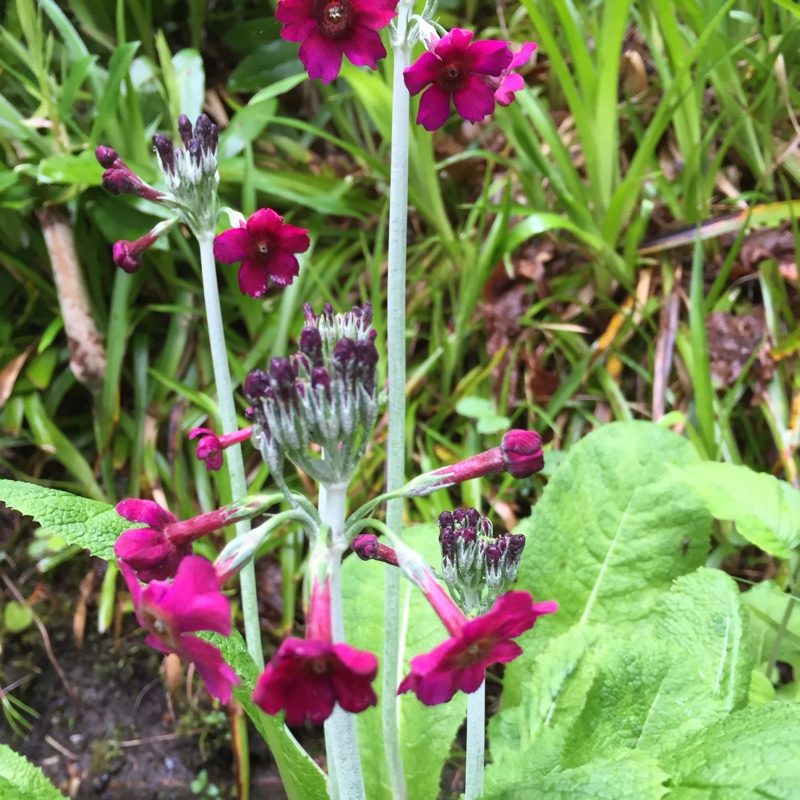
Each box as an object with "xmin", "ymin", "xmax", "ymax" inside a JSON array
[{"xmin": 397, "ymin": 583, "xmax": 558, "ymax": 706}]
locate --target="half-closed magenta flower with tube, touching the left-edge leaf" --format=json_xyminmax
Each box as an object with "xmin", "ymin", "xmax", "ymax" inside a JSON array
[{"xmin": 114, "ymin": 500, "xmax": 236, "ymax": 583}]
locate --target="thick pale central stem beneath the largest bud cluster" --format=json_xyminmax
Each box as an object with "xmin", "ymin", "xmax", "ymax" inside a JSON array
[{"xmin": 319, "ymin": 483, "xmax": 366, "ymax": 800}]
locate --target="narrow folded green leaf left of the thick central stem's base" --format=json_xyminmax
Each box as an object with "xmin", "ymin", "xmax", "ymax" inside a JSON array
[{"xmin": 209, "ymin": 630, "xmax": 328, "ymax": 800}]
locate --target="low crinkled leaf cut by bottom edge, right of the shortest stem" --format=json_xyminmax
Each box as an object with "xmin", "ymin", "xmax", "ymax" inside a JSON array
[{"xmin": 485, "ymin": 752, "xmax": 669, "ymax": 800}]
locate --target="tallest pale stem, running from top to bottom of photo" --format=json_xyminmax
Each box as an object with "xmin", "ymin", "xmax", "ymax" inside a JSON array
[{"xmin": 383, "ymin": 0, "xmax": 414, "ymax": 800}]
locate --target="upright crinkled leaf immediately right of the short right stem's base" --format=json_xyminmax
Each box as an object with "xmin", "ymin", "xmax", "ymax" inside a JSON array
[{"xmin": 486, "ymin": 625, "xmax": 610, "ymax": 795}]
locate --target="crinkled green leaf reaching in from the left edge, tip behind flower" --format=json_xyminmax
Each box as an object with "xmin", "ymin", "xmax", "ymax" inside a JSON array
[{"xmin": 0, "ymin": 480, "xmax": 123, "ymax": 561}]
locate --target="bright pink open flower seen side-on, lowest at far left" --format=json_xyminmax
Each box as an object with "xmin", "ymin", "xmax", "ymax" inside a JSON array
[{"xmin": 120, "ymin": 556, "xmax": 239, "ymax": 703}]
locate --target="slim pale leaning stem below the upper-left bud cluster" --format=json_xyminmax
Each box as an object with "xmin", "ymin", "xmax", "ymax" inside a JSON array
[{"xmin": 197, "ymin": 234, "xmax": 264, "ymax": 670}]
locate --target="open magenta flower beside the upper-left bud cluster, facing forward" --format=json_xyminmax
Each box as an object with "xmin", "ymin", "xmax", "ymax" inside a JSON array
[{"xmin": 214, "ymin": 208, "xmax": 311, "ymax": 297}]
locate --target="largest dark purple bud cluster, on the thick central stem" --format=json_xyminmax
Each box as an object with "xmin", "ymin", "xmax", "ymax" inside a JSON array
[{"xmin": 244, "ymin": 304, "xmax": 378, "ymax": 485}]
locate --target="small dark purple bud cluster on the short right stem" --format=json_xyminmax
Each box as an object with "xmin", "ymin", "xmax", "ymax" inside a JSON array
[{"xmin": 439, "ymin": 508, "xmax": 525, "ymax": 614}]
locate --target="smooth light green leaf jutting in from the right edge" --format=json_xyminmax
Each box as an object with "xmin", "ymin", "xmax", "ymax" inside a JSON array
[{"xmin": 675, "ymin": 461, "xmax": 800, "ymax": 558}]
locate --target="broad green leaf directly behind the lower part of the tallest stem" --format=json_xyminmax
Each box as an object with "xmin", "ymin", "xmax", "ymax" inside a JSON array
[{"xmin": 342, "ymin": 525, "xmax": 466, "ymax": 800}]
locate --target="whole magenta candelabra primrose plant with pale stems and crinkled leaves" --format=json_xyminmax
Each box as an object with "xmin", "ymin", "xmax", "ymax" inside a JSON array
[{"xmin": 0, "ymin": 0, "xmax": 800, "ymax": 800}]
